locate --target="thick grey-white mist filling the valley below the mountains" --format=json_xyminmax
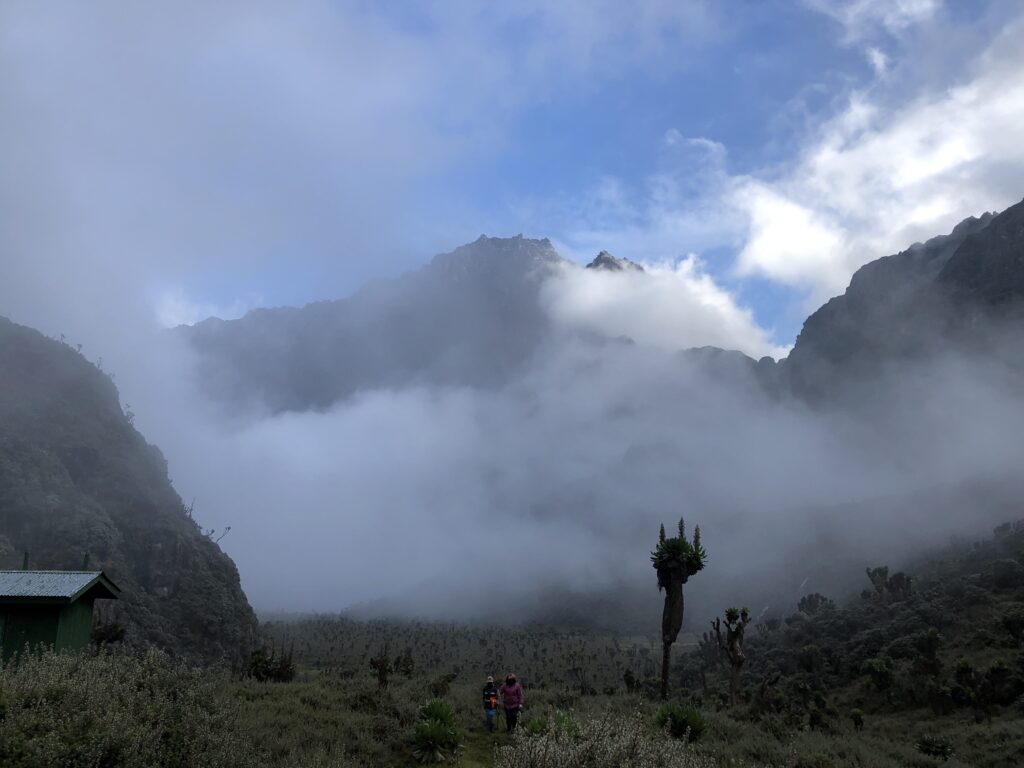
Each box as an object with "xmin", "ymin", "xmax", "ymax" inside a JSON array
[{"xmin": 121, "ymin": 270, "xmax": 1024, "ymax": 627}]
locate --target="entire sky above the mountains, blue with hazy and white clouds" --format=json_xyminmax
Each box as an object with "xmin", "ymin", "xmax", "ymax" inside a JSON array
[{"xmin": 0, "ymin": 0, "xmax": 1024, "ymax": 353}]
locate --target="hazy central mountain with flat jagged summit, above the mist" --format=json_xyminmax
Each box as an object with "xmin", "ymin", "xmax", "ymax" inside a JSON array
[{"xmin": 184, "ymin": 236, "xmax": 567, "ymax": 412}]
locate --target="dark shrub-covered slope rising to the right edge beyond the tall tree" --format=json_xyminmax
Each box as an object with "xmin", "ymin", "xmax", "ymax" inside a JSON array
[{"xmin": 681, "ymin": 520, "xmax": 1024, "ymax": 729}]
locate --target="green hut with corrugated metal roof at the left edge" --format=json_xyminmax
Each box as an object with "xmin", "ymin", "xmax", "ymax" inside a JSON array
[{"xmin": 0, "ymin": 570, "xmax": 121, "ymax": 662}]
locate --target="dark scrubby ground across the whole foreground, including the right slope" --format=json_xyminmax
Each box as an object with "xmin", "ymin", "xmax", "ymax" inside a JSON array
[{"xmin": 0, "ymin": 522, "xmax": 1024, "ymax": 768}]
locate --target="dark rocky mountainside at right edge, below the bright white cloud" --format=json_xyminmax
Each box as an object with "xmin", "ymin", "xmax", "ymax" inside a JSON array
[{"xmin": 780, "ymin": 203, "xmax": 1024, "ymax": 398}]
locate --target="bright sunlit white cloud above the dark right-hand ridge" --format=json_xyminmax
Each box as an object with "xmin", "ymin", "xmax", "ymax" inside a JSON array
[{"xmin": 732, "ymin": 15, "xmax": 1024, "ymax": 299}]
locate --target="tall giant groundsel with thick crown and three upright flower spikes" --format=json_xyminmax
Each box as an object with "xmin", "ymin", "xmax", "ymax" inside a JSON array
[{"xmin": 650, "ymin": 518, "xmax": 708, "ymax": 698}]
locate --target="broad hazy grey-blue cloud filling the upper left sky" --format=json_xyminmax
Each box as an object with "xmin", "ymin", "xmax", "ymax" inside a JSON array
[{"xmin": 0, "ymin": 0, "xmax": 716, "ymax": 342}]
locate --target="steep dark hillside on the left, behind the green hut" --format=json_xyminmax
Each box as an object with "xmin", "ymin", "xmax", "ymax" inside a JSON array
[{"xmin": 0, "ymin": 317, "xmax": 256, "ymax": 659}]
